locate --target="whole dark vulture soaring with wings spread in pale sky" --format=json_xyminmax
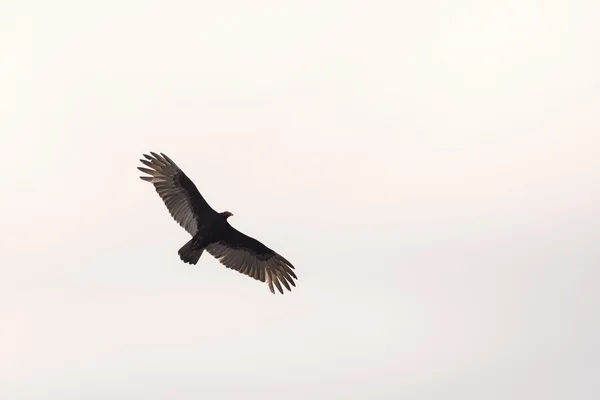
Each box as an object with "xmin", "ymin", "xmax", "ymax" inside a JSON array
[{"xmin": 138, "ymin": 151, "xmax": 298, "ymax": 294}]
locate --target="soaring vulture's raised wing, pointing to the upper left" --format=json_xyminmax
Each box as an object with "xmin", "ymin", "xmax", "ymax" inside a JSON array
[{"xmin": 138, "ymin": 152, "xmax": 216, "ymax": 236}]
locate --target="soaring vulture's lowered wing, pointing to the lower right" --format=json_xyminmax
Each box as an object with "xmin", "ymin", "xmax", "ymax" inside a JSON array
[{"xmin": 206, "ymin": 222, "xmax": 298, "ymax": 294}]
